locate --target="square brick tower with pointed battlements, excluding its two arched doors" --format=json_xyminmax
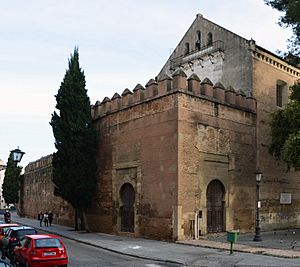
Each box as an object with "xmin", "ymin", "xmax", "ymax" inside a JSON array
[{"xmin": 88, "ymin": 69, "xmax": 256, "ymax": 239}]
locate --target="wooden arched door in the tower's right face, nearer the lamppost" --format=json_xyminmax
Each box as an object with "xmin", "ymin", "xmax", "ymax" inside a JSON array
[{"xmin": 206, "ymin": 180, "xmax": 225, "ymax": 233}]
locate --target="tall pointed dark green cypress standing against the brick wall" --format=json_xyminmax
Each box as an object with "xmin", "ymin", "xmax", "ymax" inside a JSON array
[{"xmin": 50, "ymin": 48, "xmax": 96, "ymax": 229}]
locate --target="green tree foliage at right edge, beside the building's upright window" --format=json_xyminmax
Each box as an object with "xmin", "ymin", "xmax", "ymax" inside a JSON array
[{"xmin": 269, "ymin": 81, "xmax": 300, "ymax": 170}]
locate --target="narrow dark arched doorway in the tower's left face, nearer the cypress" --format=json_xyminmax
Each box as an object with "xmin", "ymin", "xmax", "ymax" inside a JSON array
[{"xmin": 120, "ymin": 183, "xmax": 135, "ymax": 232}]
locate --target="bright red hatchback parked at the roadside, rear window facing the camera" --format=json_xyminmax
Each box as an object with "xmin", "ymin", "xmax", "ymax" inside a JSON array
[{"xmin": 13, "ymin": 234, "xmax": 68, "ymax": 267}]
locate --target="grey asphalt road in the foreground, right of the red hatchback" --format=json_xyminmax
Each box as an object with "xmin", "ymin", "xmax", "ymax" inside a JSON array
[{"xmin": 39, "ymin": 231, "xmax": 182, "ymax": 267}]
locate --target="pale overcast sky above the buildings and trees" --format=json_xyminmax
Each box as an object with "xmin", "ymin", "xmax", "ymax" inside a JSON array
[{"xmin": 0, "ymin": 0, "xmax": 291, "ymax": 167}]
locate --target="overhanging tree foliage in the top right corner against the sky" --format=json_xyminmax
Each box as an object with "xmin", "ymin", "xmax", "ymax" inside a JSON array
[{"xmin": 265, "ymin": 0, "xmax": 300, "ymax": 60}]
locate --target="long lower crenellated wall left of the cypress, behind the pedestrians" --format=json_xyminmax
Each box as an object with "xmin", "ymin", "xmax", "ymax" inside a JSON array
[{"xmin": 18, "ymin": 155, "xmax": 74, "ymax": 226}]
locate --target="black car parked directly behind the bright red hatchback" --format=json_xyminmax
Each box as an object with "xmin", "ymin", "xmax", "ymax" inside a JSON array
[{"xmin": 1, "ymin": 226, "xmax": 37, "ymax": 259}]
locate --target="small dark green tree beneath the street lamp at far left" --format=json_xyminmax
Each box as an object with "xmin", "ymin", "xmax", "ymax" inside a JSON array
[{"xmin": 2, "ymin": 154, "xmax": 22, "ymax": 204}]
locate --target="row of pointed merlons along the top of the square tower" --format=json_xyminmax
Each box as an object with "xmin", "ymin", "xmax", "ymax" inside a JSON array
[{"xmin": 92, "ymin": 68, "xmax": 256, "ymax": 119}]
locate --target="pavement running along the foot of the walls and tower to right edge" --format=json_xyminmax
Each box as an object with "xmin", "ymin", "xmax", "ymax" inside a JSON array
[{"xmin": 12, "ymin": 213, "xmax": 300, "ymax": 267}]
